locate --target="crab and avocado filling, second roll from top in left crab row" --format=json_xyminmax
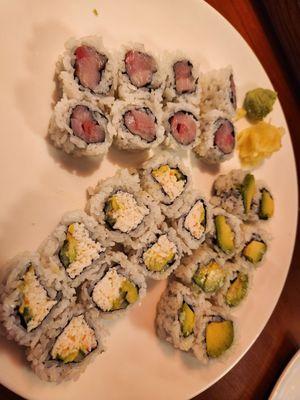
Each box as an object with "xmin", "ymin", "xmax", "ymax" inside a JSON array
[{"xmin": 104, "ymin": 190, "xmax": 150, "ymax": 233}]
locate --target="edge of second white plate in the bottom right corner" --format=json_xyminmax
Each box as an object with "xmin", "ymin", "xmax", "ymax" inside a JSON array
[{"xmin": 269, "ymin": 350, "xmax": 300, "ymax": 400}]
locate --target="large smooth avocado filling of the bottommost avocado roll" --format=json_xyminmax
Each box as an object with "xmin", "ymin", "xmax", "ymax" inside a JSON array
[{"xmin": 205, "ymin": 317, "xmax": 234, "ymax": 358}]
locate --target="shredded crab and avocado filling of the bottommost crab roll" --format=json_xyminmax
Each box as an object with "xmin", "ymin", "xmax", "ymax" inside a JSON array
[{"xmin": 51, "ymin": 315, "xmax": 97, "ymax": 364}]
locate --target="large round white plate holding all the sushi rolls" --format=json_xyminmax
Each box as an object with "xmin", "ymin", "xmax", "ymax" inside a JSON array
[{"xmin": 0, "ymin": 0, "xmax": 297, "ymax": 400}]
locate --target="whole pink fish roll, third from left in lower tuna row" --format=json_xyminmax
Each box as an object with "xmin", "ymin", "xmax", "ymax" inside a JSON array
[{"xmin": 164, "ymin": 103, "xmax": 201, "ymax": 149}]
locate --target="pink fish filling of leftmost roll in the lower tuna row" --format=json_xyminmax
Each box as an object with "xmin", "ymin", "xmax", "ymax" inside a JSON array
[{"xmin": 70, "ymin": 105, "xmax": 105, "ymax": 143}]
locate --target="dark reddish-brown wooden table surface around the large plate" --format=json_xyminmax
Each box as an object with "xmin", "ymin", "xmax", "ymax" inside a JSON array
[{"xmin": 0, "ymin": 0, "xmax": 300, "ymax": 400}]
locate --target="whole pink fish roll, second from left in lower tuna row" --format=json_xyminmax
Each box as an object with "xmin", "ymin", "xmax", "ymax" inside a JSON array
[{"xmin": 112, "ymin": 100, "xmax": 165, "ymax": 150}]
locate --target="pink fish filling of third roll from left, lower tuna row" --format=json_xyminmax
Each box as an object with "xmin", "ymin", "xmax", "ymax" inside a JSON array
[{"xmin": 169, "ymin": 111, "xmax": 197, "ymax": 146}]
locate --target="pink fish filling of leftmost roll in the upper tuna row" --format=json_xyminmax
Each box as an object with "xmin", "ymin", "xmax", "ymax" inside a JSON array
[{"xmin": 75, "ymin": 45, "xmax": 107, "ymax": 90}]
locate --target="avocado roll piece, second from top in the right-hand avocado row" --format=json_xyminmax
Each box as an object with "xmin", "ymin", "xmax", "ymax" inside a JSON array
[{"xmin": 240, "ymin": 225, "xmax": 270, "ymax": 268}]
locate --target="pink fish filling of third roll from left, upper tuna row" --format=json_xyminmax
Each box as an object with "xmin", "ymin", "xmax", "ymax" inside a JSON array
[{"xmin": 173, "ymin": 60, "xmax": 195, "ymax": 94}]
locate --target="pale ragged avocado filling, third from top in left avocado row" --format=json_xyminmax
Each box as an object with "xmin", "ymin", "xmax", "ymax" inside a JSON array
[{"xmin": 193, "ymin": 260, "xmax": 225, "ymax": 293}]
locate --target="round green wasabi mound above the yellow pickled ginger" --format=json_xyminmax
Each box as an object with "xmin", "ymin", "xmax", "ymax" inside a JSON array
[{"xmin": 243, "ymin": 88, "xmax": 277, "ymax": 121}]
